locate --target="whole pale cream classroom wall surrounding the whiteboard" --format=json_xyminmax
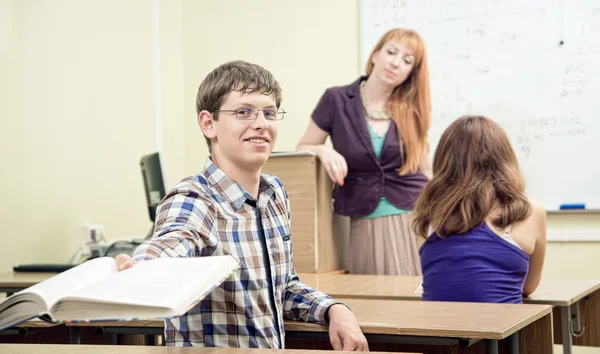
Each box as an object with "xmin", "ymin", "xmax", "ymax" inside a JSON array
[{"xmin": 0, "ymin": 0, "xmax": 600, "ymax": 278}]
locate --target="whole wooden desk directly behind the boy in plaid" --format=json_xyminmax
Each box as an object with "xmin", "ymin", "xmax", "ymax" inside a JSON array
[{"xmin": 47, "ymin": 299, "xmax": 552, "ymax": 354}]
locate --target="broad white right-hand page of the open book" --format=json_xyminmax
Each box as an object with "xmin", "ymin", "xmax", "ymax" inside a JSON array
[{"xmin": 65, "ymin": 256, "xmax": 239, "ymax": 309}]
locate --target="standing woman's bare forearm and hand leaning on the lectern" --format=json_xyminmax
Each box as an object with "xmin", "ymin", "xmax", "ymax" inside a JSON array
[{"xmin": 296, "ymin": 119, "xmax": 348, "ymax": 186}]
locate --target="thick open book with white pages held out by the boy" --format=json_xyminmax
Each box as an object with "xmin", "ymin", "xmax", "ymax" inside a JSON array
[{"xmin": 0, "ymin": 256, "xmax": 239, "ymax": 330}]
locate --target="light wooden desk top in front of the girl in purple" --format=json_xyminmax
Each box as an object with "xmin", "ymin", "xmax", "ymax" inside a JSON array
[{"xmin": 299, "ymin": 273, "xmax": 600, "ymax": 306}]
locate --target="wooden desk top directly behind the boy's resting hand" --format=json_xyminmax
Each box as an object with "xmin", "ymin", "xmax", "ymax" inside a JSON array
[{"xmin": 54, "ymin": 299, "xmax": 552, "ymax": 339}]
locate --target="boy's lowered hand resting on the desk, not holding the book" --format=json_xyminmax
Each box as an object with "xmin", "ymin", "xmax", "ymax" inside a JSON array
[{"xmin": 328, "ymin": 304, "xmax": 369, "ymax": 352}]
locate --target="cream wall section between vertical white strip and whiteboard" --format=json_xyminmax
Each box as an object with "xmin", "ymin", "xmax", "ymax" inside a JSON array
[{"xmin": 182, "ymin": 0, "xmax": 359, "ymax": 174}]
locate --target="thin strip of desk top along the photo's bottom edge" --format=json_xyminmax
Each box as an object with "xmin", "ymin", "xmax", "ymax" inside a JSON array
[{"xmin": 0, "ymin": 344, "xmax": 416, "ymax": 354}]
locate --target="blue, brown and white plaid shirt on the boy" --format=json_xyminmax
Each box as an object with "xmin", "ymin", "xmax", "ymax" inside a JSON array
[{"xmin": 133, "ymin": 159, "xmax": 337, "ymax": 348}]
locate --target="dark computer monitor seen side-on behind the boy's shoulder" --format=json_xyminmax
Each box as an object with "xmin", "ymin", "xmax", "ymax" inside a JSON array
[{"xmin": 140, "ymin": 152, "xmax": 165, "ymax": 222}]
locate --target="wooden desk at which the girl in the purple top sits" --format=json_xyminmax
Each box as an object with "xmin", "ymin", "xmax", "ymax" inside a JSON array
[{"xmin": 300, "ymin": 273, "xmax": 600, "ymax": 354}]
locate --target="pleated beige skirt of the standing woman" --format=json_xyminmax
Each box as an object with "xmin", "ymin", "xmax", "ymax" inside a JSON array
[{"xmin": 348, "ymin": 213, "xmax": 421, "ymax": 275}]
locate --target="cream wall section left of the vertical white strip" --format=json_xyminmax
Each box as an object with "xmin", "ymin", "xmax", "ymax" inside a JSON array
[{"xmin": 0, "ymin": 0, "xmax": 166, "ymax": 271}]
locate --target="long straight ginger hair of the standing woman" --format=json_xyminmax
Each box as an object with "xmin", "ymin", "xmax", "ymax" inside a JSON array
[{"xmin": 366, "ymin": 28, "xmax": 431, "ymax": 175}]
